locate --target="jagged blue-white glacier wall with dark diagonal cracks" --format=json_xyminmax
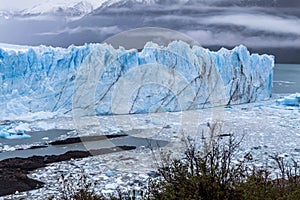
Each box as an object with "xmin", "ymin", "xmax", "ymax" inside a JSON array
[{"xmin": 0, "ymin": 41, "xmax": 274, "ymax": 119}]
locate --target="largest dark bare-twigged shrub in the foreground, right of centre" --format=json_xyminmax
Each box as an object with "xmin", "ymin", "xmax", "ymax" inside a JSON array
[{"xmin": 149, "ymin": 133, "xmax": 247, "ymax": 200}]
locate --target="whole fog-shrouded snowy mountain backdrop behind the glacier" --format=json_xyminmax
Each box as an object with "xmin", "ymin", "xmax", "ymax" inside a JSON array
[{"xmin": 0, "ymin": 0, "xmax": 300, "ymax": 63}]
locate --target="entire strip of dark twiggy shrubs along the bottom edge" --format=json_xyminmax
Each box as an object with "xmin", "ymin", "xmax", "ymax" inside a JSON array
[{"xmin": 54, "ymin": 124, "xmax": 300, "ymax": 200}]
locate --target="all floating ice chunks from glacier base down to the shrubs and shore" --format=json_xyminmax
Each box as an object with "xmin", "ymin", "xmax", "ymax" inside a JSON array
[{"xmin": 2, "ymin": 95, "xmax": 300, "ymax": 199}]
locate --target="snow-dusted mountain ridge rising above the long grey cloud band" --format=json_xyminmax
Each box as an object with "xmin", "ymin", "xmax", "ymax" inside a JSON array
[{"xmin": 0, "ymin": 0, "xmax": 300, "ymax": 18}]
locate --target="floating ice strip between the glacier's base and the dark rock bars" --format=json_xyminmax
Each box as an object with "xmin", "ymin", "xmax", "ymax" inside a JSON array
[{"xmin": 0, "ymin": 94, "xmax": 300, "ymax": 153}]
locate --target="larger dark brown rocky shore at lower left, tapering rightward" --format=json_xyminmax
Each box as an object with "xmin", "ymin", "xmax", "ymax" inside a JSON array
[{"xmin": 0, "ymin": 146, "xmax": 136, "ymax": 196}]
